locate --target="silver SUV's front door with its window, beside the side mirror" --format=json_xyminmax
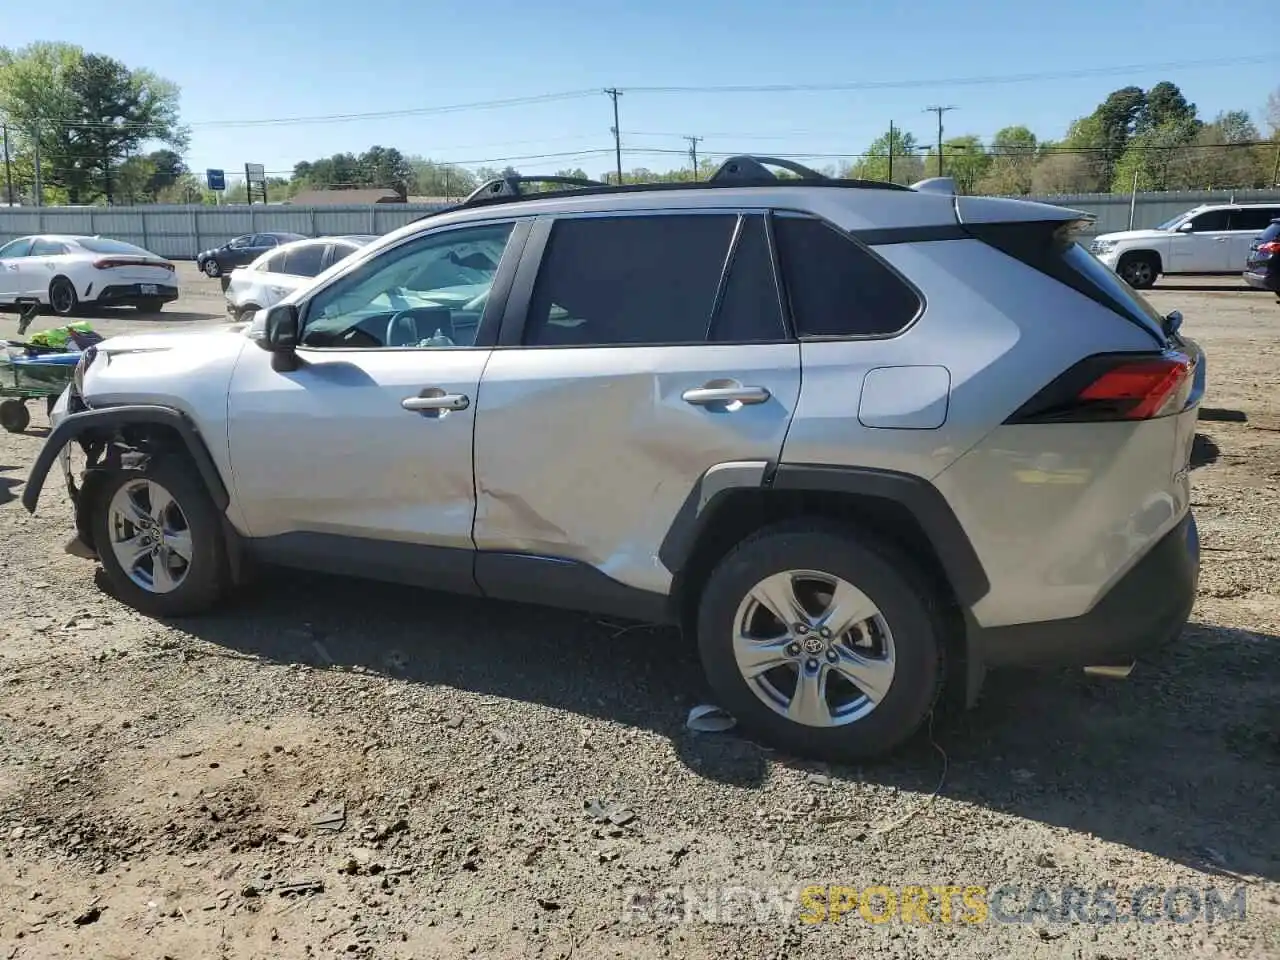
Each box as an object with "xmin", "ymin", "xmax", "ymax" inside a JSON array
[{"xmin": 229, "ymin": 221, "xmax": 527, "ymax": 590}]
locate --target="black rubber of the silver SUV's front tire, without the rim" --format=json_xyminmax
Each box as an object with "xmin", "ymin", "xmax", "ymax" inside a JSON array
[{"xmin": 90, "ymin": 456, "xmax": 228, "ymax": 617}]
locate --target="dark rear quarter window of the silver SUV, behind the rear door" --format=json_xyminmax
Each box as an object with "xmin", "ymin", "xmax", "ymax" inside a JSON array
[{"xmin": 773, "ymin": 214, "xmax": 923, "ymax": 339}]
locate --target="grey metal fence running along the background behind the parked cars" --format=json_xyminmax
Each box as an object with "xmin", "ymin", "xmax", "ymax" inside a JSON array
[{"xmin": 0, "ymin": 189, "xmax": 1280, "ymax": 260}]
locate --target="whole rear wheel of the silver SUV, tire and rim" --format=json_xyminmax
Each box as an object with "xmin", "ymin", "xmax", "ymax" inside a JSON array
[{"xmin": 698, "ymin": 522, "xmax": 943, "ymax": 762}]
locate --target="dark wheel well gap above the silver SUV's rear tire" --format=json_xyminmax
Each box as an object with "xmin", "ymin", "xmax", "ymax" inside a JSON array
[{"xmin": 672, "ymin": 488, "xmax": 968, "ymax": 701}]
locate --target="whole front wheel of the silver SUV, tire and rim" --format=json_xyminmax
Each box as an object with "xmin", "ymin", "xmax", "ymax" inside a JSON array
[{"xmin": 91, "ymin": 457, "xmax": 227, "ymax": 617}]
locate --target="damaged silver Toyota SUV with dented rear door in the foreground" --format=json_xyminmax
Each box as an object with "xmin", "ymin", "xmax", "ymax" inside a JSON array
[{"xmin": 23, "ymin": 157, "xmax": 1204, "ymax": 760}]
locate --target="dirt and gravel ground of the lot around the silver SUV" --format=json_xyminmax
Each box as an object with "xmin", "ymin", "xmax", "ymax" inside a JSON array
[{"xmin": 0, "ymin": 271, "xmax": 1280, "ymax": 960}]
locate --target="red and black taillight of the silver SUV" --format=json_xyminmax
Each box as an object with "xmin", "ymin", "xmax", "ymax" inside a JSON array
[{"xmin": 1006, "ymin": 351, "xmax": 1194, "ymax": 424}]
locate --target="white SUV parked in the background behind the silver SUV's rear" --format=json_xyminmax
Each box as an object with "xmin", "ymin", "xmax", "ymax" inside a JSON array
[{"xmin": 1091, "ymin": 202, "xmax": 1280, "ymax": 289}]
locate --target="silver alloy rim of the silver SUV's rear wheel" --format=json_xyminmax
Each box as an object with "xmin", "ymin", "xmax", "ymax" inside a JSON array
[{"xmin": 733, "ymin": 570, "xmax": 895, "ymax": 727}]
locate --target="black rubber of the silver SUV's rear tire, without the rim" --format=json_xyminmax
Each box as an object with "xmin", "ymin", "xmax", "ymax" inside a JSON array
[{"xmin": 698, "ymin": 521, "xmax": 945, "ymax": 762}]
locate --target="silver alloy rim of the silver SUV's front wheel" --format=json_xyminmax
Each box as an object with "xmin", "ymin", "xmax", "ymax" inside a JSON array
[{"xmin": 108, "ymin": 480, "xmax": 191, "ymax": 594}]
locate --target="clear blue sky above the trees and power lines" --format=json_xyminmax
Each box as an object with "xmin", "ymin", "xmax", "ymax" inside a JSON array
[{"xmin": 0, "ymin": 0, "xmax": 1280, "ymax": 184}]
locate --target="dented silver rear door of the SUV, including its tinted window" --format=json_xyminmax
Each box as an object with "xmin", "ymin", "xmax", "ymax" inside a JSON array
[{"xmin": 475, "ymin": 210, "xmax": 800, "ymax": 605}]
